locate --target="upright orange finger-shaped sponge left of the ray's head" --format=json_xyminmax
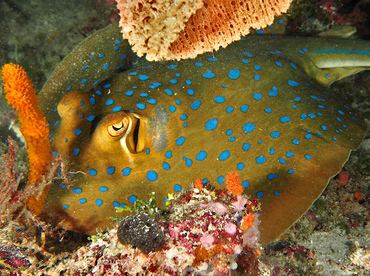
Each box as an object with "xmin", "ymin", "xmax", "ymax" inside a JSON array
[{"xmin": 1, "ymin": 63, "xmax": 52, "ymax": 183}]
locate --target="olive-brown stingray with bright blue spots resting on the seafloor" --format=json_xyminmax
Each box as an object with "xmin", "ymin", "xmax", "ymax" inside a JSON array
[{"xmin": 36, "ymin": 22, "xmax": 370, "ymax": 243}]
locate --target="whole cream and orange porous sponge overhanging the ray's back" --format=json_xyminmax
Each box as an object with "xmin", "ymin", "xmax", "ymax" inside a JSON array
[{"xmin": 116, "ymin": 0, "xmax": 292, "ymax": 61}]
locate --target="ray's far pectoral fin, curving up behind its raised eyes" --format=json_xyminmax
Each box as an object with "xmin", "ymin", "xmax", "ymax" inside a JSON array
[{"xmin": 39, "ymin": 23, "xmax": 137, "ymax": 114}]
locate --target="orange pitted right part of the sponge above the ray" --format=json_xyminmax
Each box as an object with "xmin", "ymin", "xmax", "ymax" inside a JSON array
[{"xmin": 167, "ymin": 0, "xmax": 291, "ymax": 59}]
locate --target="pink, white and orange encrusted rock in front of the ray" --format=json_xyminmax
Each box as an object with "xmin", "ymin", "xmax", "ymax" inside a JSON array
[{"xmin": 20, "ymin": 174, "xmax": 260, "ymax": 275}]
